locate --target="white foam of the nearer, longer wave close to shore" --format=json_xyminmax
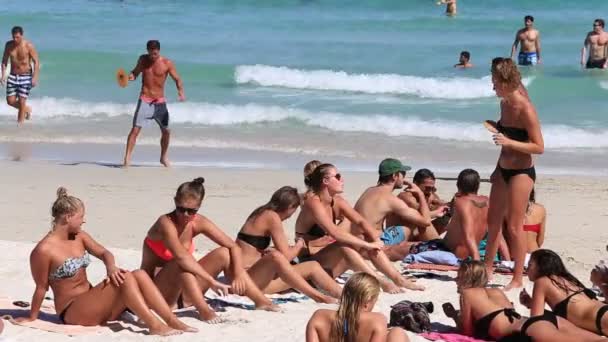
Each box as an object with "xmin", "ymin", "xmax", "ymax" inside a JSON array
[{"xmin": 0, "ymin": 98, "xmax": 608, "ymax": 148}]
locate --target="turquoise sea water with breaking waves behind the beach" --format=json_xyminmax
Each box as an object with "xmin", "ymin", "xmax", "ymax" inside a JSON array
[{"xmin": 0, "ymin": 0, "xmax": 608, "ymax": 174}]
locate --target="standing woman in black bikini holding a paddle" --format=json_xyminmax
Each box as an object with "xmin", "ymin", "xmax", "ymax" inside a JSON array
[{"xmin": 485, "ymin": 57, "xmax": 544, "ymax": 290}]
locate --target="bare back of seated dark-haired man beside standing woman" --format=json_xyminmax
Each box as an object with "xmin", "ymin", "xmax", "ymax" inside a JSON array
[{"xmin": 444, "ymin": 194, "xmax": 489, "ymax": 259}]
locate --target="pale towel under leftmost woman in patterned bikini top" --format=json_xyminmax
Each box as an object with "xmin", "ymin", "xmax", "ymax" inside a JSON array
[{"xmin": 0, "ymin": 298, "xmax": 103, "ymax": 336}]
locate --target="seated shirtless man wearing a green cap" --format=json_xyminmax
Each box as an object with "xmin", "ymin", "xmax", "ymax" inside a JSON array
[{"xmin": 352, "ymin": 158, "xmax": 431, "ymax": 274}]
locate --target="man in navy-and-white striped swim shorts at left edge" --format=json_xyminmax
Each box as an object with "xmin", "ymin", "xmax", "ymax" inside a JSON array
[{"xmin": 0, "ymin": 26, "xmax": 40, "ymax": 124}]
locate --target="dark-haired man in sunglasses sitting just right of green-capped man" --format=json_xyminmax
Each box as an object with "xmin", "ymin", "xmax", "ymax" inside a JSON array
[{"xmin": 386, "ymin": 169, "xmax": 450, "ymax": 241}]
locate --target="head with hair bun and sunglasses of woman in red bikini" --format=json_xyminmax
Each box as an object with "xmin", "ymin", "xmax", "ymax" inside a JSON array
[{"xmin": 173, "ymin": 177, "xmax": 205, "ymax": 224}]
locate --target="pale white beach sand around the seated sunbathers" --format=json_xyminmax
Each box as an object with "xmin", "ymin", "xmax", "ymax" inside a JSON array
[{"xmin": 0, "ymin": 162, "xmax": 608, "ymax": 342}]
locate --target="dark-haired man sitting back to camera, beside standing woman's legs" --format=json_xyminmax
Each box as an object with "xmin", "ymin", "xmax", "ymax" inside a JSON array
[{"xmin": 386, "ymin": 169, "xmax": 489, "ymax": 261}]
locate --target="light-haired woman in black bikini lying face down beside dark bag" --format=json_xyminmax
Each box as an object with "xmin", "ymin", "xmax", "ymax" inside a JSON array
[{"xmin": 444, "ymin": 260, "xmax": 600, "ymax": 342}]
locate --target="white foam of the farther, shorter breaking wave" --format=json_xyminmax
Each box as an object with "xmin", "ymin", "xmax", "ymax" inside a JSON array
[{"xmin": 234, "ymin": 65, "xmax": 532, "ymax": 99}]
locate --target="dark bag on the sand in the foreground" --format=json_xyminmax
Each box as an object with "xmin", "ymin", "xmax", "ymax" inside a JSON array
[{"xmin": 388, "ymin": 300, "xmax": 433, "ymax": 333}]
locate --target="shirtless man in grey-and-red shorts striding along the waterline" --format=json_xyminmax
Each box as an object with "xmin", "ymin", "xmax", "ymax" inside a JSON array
[{"xmin": 123, "ymin": 40, "xmax": 186, "ymax": 167}]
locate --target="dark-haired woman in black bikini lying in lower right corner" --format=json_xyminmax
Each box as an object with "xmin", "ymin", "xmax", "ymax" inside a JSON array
[{"xmin": 522, "ymin": 249, "xmax": 608, "ymax": 335}]
